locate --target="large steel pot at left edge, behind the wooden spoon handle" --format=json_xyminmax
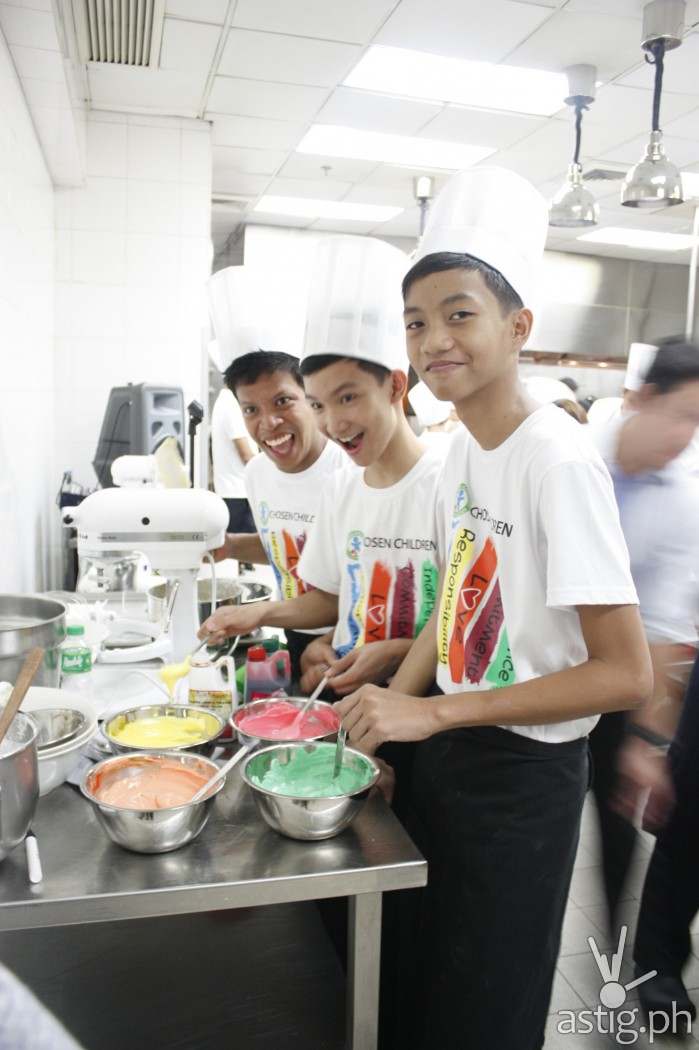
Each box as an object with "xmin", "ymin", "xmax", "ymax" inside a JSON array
[{"xmin": 0, "ymin": 594, "xmax": 65, "ymax": 689}]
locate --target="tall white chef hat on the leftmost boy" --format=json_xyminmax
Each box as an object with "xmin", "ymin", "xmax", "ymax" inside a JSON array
[{"xmin": 207, "ymin": 266, "xmax": 289, "ymax": 372}]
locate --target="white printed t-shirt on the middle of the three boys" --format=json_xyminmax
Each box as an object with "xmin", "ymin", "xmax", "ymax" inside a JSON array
[{"xmin": 299, "ymin": 450, "xmax": 443, "ymax": 656}]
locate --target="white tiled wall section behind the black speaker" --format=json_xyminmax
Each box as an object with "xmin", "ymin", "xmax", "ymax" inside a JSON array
[{"xmin": 56, "ymin": 112, "xmax": 212, "ymax": 486}]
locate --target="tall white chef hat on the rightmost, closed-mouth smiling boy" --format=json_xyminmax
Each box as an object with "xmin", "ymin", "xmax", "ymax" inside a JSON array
[{"xmin": 415, "ymin": 167, "xmax": 549, "ymax": 308}]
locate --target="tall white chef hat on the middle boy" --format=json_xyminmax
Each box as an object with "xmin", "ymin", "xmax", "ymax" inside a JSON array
[{"xmin": 301, "ymin": 236, "xmax": 408, "ymax": 372}]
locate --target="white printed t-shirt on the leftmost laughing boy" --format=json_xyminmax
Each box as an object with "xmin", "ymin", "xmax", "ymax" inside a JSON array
[{"xmin": 245, "ymin": 441, "xmax": 346, "ymax": 634}]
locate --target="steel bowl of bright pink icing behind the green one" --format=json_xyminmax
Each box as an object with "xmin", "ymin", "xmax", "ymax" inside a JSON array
[{"xmin": 232, "ymin": 696, "xmax": 340, "ymax": 746}]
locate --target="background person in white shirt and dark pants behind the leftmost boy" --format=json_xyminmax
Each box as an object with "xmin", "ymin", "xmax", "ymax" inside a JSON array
[{"xmin": 211, "ymin": 386, "xmax": 255, "ymax": 532}]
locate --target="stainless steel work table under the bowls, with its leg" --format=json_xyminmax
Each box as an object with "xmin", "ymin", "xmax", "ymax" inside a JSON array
[{"xmin": 0, "ymin": 772, "xmax": 427, "ymax": 1050}]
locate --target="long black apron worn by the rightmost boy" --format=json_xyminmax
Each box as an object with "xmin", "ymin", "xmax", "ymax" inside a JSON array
[{"xmin": 382, "ymin": 728, "xmax": 589, "ymax": 1050}]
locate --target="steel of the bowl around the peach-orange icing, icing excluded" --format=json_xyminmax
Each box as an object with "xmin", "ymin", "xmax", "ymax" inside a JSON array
[{"xmin": 80, "ymin": 751, "xmax": 225, "ymax": 854}]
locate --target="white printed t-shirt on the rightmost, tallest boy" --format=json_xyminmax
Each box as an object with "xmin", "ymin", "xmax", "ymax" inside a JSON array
[{"xmin": 437, "ymin": 405, "xmax": 637, "ymax": 743}]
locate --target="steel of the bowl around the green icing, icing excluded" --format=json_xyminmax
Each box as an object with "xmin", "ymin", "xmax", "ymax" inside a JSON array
[{"xmin": 240, "ymin": 743, "xmax": 380, "ymax": 841}]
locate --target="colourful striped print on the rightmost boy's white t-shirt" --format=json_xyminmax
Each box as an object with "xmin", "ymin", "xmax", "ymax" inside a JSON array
[{"xmin": 437, "ymin": 484, "xmax": 516, "ymax": 688}]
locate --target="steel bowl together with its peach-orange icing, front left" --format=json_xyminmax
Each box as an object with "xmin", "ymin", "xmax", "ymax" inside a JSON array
[{"xmin": 80, "ymin": 751, "xmax": 225, "ymax": 854}]
